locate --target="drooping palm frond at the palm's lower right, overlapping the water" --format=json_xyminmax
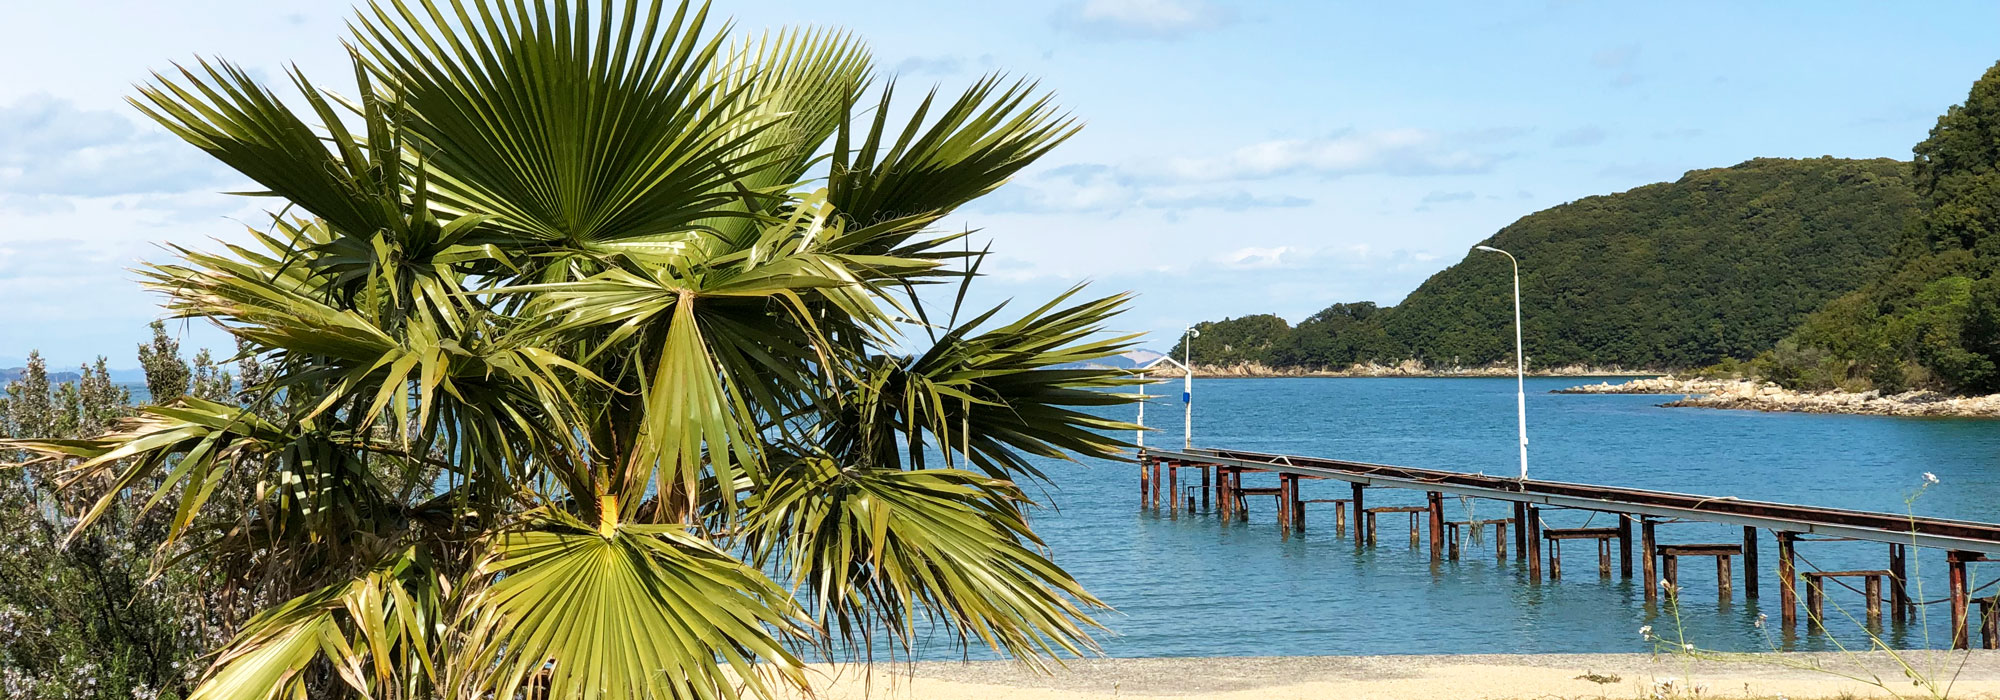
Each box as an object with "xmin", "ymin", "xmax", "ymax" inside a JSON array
[{"xmin": 748, "ymin": 458, "xmax": 1102, "ymax": 664}]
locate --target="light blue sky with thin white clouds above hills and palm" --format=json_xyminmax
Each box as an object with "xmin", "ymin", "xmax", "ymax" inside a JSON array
[{"xmin": 0, "ymin": 0, "xmax": 2000, "ymax": 368}]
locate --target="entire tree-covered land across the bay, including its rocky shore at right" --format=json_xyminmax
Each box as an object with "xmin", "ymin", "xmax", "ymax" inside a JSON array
[{"xmin": 1172, "ymin": 66, "xmax": 2000, "ymax": 416}]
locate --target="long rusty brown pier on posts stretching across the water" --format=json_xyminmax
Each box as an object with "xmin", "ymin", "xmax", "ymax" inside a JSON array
[{"xmin": 1138, "ymin": 446, "xmax": 2000, "ymax": 648}]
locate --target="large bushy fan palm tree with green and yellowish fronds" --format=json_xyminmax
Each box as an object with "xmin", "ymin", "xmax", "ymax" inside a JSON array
[{"xmin": 10, "ymin": 0, "xmax": 1130, "ymax": 700}]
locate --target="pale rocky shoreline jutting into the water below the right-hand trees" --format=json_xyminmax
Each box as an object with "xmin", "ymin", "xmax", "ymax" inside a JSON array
[{"xmin": 1552, "ymin": 376, "xmax": 2000, "ymax": 418}]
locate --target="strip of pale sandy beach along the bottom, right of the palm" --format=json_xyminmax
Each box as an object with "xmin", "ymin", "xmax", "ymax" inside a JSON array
[{"xmin": 780, "ymin": 652, "xmax": 2000, "ymax": 700}]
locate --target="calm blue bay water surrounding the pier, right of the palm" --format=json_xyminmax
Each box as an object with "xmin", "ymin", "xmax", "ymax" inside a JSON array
[{"xmin": 1000, "ymin": 378, "xmax": 2000, "ymax": 656}]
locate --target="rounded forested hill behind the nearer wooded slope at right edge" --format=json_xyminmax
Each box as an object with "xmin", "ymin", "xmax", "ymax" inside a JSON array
[{"xmin": 1174, "ymin": 158, "xmax": 1918, "ymax": 368}]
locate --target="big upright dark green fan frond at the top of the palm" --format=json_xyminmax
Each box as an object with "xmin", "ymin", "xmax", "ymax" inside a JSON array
[{"xmin": 356, "ymin": 0, "xmax": 778, "ymax": 250}]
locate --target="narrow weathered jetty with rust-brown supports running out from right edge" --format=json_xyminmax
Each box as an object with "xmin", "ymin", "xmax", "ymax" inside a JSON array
[{"xmin": 1138, "ymin": 446, "xmax": 2000, "ymax": 648}]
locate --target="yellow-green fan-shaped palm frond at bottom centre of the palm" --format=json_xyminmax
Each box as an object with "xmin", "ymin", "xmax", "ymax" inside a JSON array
[{"xmin": 460, "ymin": 506, "xmax": 804, "ymax": 700}]
